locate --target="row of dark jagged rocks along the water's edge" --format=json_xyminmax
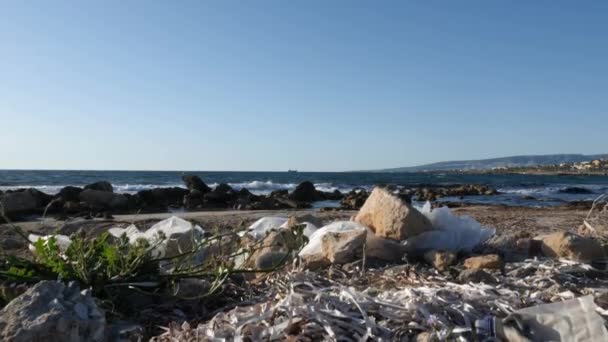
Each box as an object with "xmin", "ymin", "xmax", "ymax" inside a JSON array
[{"xmin": 0, "ymin": 175, "xmax": 497, "ymax": 221}]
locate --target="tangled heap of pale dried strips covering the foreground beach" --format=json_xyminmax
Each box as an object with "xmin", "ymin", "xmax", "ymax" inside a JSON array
[{"xmin": 154, "ymin": 259, "xmax": 608, "ymax": 341}]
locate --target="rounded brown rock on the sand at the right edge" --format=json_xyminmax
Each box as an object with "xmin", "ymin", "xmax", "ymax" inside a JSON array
[{"xmin": 536, "ymin": 232, "xmax": 606, "ymax": 263}]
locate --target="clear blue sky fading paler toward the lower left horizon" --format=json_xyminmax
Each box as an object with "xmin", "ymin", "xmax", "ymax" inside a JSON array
[{"xmin": 0, "ymin": 1, "xmax": 608, "ymax": 171}]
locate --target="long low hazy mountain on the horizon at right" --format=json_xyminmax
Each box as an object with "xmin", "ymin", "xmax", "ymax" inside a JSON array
[{"xmin": 375, "ymin": 154, "xmax": 608, "ymax": 172}]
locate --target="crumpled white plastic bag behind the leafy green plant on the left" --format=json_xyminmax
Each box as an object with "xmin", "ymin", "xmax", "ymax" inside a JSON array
[{"xmin": 108, "ymin": 216, "xmax": 204, "ymax": 258}]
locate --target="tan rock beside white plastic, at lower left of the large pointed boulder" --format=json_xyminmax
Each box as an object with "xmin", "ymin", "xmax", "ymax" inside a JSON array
[{"xmin": 321, "ymin": 230, "xmax": 367, "ymax": 264}]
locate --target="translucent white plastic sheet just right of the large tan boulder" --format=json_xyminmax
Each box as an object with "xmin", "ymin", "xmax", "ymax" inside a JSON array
[{"xmin": 405, "ymin": 202, "xmax": 496, "ymax": 254}]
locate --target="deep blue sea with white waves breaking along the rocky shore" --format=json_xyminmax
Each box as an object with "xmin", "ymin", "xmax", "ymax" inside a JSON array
[{"xmin": 0, "ymin": 170, "xmax": 608, "ymax": 207}]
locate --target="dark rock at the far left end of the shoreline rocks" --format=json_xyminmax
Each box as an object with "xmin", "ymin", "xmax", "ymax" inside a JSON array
[{"xmin": 0, "ymin": 189, "xmax": 52, "ymax": 218}]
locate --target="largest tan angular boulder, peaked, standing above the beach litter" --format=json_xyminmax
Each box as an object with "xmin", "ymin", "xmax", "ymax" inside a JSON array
[{"xmin": 355, "ymin": 187, "xmax": 433, "ymax": 241}]
